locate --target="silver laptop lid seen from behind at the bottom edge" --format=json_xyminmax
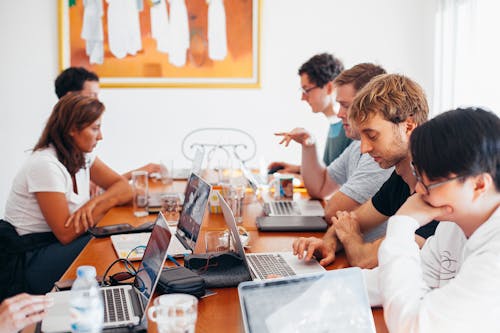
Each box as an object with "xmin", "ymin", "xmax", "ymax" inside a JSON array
[{"xmin": 238, "ymin": 267, "xmax": 375, "ymax": 333}]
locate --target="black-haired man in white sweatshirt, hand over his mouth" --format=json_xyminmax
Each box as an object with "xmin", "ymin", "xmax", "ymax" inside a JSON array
[{"xmin": 364, "ymin": 108, "xmax": 500, "ymax": 332}]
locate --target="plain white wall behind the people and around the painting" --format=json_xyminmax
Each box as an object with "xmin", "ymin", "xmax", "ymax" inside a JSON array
[{"xmin": 0, "ymin": 0, "xmax": 435, "ymax": 217}]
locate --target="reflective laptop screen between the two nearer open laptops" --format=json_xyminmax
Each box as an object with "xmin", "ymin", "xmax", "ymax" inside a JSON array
[{"xmin": 177, "ymin": 173, "xmax": 211, "ymax": 250}]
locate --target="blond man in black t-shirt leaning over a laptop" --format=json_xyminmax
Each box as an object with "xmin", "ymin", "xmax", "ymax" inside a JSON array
[{"xmin": 293, "ymin": 74, "xmax": 437, "ymax": 268}]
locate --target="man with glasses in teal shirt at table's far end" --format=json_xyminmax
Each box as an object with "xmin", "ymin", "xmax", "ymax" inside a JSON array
[{"xmin": 268, "ymin": 53, "xmax": 352, "ymax": 173}]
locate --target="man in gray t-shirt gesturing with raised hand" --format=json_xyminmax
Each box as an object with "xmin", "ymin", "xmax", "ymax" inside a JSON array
[{"xmin": 274, "ymin": 63, "xmax": 392, "ymax": 221}]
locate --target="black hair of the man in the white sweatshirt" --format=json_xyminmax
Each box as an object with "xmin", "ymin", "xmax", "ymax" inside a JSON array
[{"xmin": 410, "ymin": 107, "xmax": 500, "ymax": 191}]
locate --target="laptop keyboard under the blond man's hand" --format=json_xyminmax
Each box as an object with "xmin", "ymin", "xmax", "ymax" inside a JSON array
[{"xmin": 247, "ymin": 253, "xmax": 296, "ymax": 279}]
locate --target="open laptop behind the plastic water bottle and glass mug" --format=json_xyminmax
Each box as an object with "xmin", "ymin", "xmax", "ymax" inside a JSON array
[{"xmin": 42, "ymin": 211, "xmax": 172, "ymax": 333}]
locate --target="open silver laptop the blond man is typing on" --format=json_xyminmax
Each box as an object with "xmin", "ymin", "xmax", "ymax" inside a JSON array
[{"xmin": 217, "ymin": 193, "xmax": 325, "ymax": 280}]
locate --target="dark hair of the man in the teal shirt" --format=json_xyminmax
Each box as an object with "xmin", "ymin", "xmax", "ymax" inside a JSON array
[{"xmin": 299, "ymin": 53, "xmax": 344, "ymax": 88}]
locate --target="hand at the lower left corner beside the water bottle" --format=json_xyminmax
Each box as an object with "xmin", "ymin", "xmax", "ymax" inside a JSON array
[{"xmin": 0, "ymin": 293, "xmax": 53, "ymax": 333}]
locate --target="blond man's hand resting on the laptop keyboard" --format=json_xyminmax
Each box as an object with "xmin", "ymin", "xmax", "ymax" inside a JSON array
[{"xmin": 293, "ymin": 237, "xmax": 337, "ymax": 266}]
